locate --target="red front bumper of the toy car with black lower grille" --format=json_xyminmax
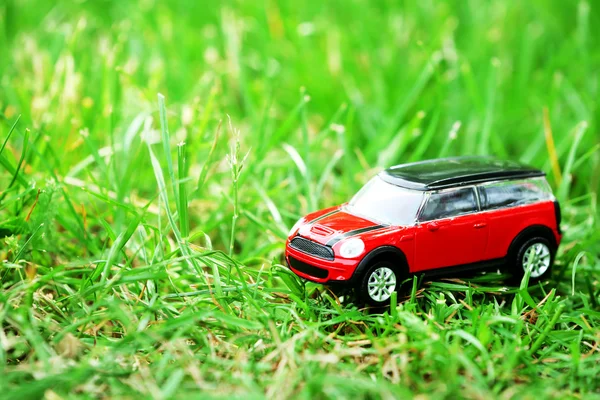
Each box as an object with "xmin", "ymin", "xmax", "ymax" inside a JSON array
[{"xmin": 285, "ymin": 240, "xmax": 360, "ymax": 283}]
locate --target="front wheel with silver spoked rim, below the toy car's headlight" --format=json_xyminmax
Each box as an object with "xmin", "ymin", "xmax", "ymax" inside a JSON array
[{"xmin": 357, "ymin": 261, "xmax": 401, "ymax": 306}]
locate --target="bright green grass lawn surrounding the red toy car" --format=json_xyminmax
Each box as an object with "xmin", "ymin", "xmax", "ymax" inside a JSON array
[{"xmin": 0, "ymin": 0, "xmax": 600, "ymax": 399}]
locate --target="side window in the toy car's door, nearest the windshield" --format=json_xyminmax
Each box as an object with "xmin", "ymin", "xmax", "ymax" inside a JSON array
[{"xmin": 419, "ymin": 187, "xmax": 477, "ymax": 221}]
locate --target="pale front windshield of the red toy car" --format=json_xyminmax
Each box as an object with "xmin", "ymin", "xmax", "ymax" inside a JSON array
[{"xmin": 347, "ymin": 176, "xmax": 424, "ymax": 225}]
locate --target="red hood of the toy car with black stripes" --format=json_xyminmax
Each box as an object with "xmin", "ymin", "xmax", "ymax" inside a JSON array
[{"xmin": 298, "ymin": 207, "xmax": 391, "ymax": 246}]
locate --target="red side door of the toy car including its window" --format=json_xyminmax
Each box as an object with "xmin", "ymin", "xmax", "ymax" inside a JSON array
[{"xmin": 414, "ymin": 187, "xmax": 488, "ymax": 271}]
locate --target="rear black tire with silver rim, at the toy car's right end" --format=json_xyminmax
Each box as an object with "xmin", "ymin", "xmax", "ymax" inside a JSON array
[{"xmin": 509, "ymin": 236, "xmax": 556, "ymax": 283}]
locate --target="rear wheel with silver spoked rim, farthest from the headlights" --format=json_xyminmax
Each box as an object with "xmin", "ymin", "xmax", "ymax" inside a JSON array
[{"xmin": 514, "ymin": 237, "xmax": 556, "ymax": 281}]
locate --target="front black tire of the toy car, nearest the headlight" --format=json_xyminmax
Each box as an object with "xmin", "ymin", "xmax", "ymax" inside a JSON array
[{"xmin": 355, "ymin": 261, "xmax": 404, "ymax": 307}]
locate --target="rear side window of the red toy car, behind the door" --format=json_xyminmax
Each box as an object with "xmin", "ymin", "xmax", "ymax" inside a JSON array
[{"xmin": 478, "ymin": 177, "xmax": 554, "ymax": 210}]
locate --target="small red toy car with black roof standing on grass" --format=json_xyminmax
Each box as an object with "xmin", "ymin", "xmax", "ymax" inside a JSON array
[{"xmin": 285, "ymin": 157, "xmax": 562, "ymax": 306}]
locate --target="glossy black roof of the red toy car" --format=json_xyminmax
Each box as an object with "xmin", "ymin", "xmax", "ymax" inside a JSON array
[{"xmin": 379, "ymin": 157, "xmax": 545, "ymax": 190}]
